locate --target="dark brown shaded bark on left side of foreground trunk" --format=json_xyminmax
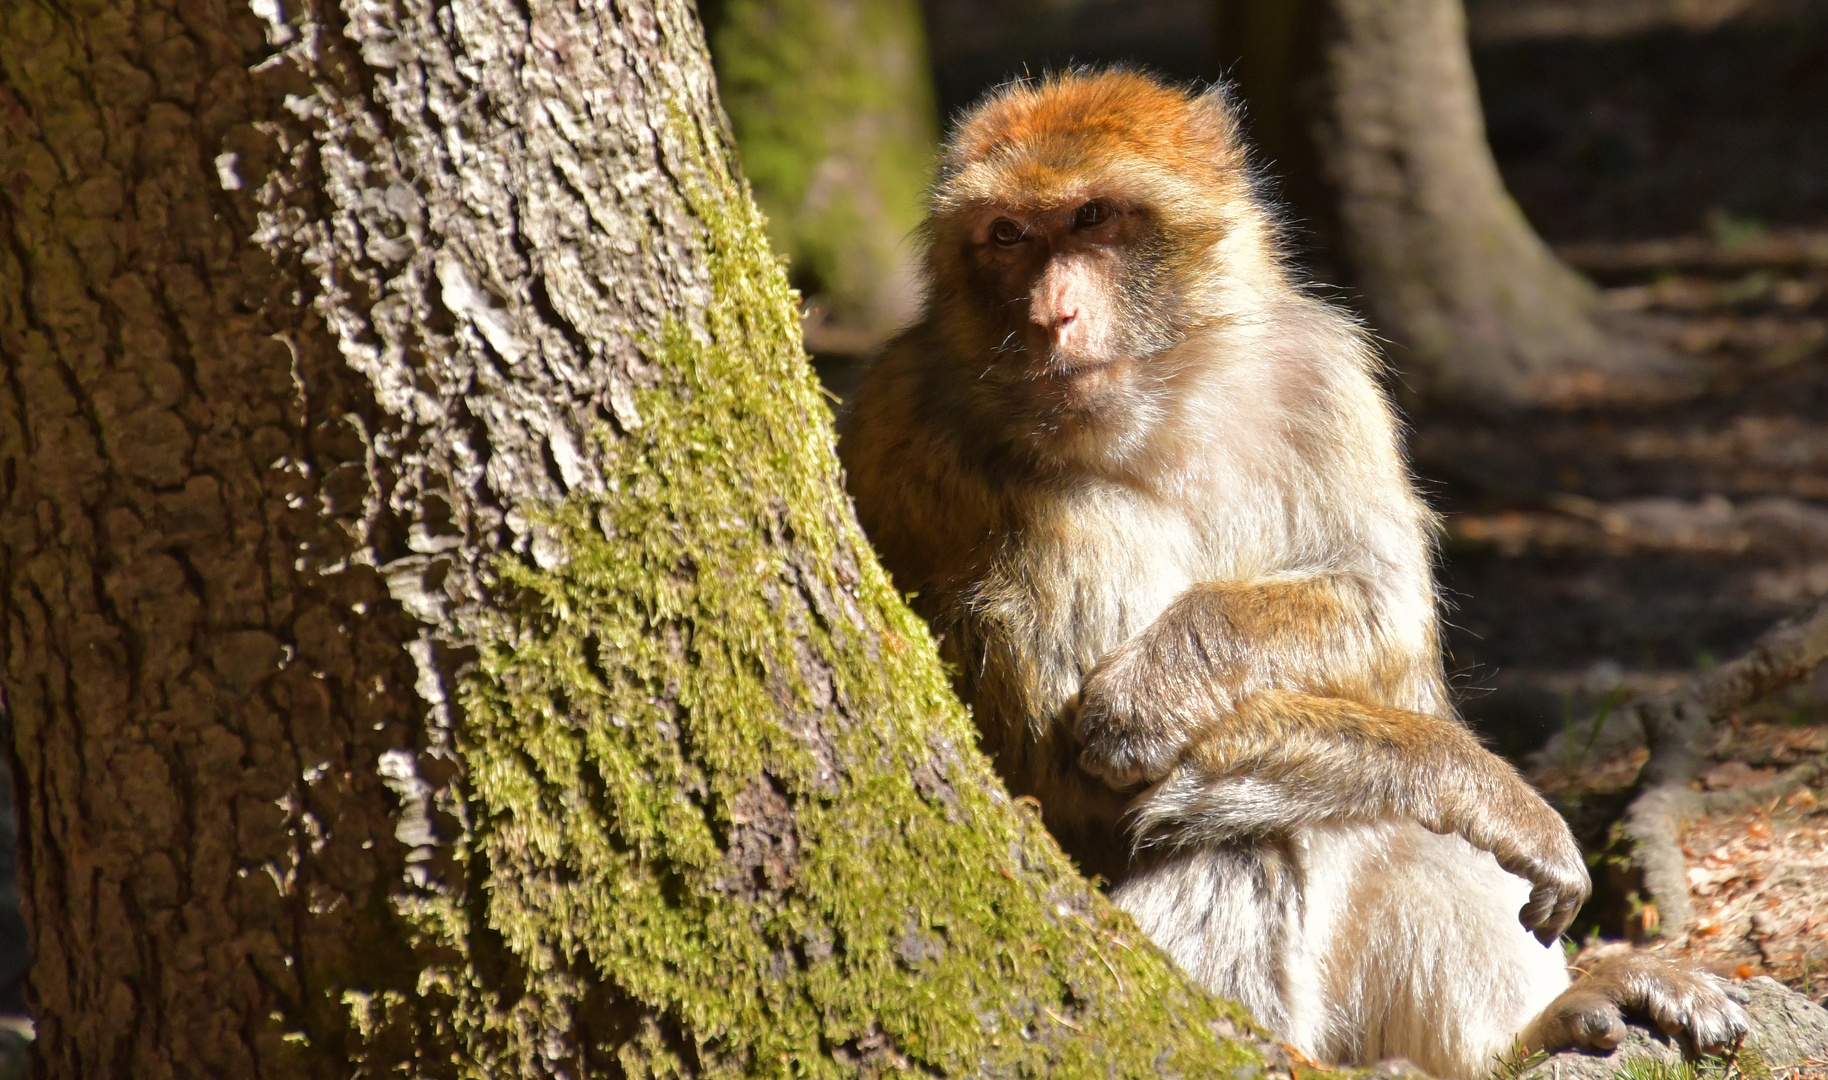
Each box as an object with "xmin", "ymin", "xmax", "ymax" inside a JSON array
[{"xmin": 0, "ymin": 0, "xmax": 424, "ymax": 1076}]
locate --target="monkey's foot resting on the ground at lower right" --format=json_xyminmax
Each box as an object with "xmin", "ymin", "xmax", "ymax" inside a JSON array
[{"xmin": 1523, "ymin": 945, "xmax": 1751, "ymax": 1054}]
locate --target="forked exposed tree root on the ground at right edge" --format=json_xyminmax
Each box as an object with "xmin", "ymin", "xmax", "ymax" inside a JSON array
[{"xmin": 1621, "ymin": 598, "xmax": 1828, "ymax": 937}]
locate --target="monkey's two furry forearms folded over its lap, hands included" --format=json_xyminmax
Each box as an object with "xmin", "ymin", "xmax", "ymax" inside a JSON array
[{"xmin": 1075, "ymin": 574, "xmax": 1589, "ymax": 939}]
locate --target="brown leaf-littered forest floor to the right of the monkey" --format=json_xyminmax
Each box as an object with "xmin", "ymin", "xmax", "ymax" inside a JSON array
[{"xmin": 1411, "ymin": 228, "xmax": 1828, "ymax": 1001}]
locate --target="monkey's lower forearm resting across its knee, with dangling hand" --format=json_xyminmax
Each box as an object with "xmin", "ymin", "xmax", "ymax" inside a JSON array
[{"xmin": 1132, "ymin": 691, "xmax": 1590, "ymax": 941}]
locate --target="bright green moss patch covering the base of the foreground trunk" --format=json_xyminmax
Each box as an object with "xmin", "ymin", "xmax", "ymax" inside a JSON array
[{"xmin": 378, "ymin": 139, "xmax": 1259, "ymax": 1076}]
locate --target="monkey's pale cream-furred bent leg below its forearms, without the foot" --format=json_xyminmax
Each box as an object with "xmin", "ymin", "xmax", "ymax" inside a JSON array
[{"xmin": 1111, "ymin": 821, "xmax": 1568, "ymax": 1076}]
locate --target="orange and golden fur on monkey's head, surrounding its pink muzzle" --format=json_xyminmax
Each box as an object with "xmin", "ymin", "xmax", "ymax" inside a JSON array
[{"xmin": 923, "ymin": 69, "xmax": 1289, "ymax": 420}]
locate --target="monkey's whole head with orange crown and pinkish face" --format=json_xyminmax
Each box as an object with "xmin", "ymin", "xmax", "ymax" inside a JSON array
[{"xmin": 925, "ymin": 71, "xmax": 1283, "ymax": 466}]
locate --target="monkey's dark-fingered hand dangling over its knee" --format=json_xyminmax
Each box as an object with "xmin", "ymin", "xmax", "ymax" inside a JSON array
[{"xmin": 1424, "ymin": 778, "xmax": 1592, "ymax": 945}]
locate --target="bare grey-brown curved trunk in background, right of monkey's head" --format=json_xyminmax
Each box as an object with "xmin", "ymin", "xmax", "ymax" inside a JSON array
[{"xmin": 1219, "ymin": 0, "xmax": 1695, "ymax": 408}]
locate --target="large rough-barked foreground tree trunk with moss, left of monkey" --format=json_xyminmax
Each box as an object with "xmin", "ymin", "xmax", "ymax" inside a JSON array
[{"xmin": 0, "ymin": 0, "xmax": 1256, "ymax": 1080}]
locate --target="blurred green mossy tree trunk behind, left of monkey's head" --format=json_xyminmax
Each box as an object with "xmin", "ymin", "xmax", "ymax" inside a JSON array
[{"xmin": 700, "ymin": 0, "xmax": 938, "ymax": 355}]
